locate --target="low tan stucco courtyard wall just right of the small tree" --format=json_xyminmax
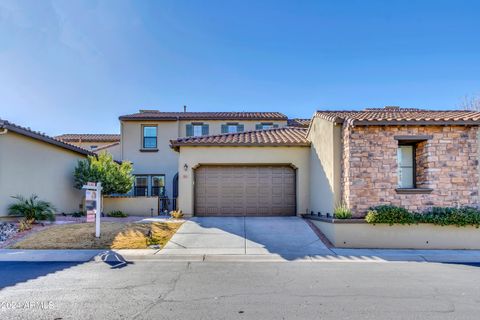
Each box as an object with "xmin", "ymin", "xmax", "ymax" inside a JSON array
[{"xmin": 103, "ymin": 197, "xmax": 158, "ymax": 217}]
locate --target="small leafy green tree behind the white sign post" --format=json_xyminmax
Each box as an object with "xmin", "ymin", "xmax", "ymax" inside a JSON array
[{"xmin": 74, "ymin": 152, "xmax": 133, "ymax": 195}]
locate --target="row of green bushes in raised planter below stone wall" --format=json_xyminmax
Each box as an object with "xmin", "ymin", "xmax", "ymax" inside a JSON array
[{"xmin": 365, "ymin": 205, "xmax": 480, "ymax": 228}]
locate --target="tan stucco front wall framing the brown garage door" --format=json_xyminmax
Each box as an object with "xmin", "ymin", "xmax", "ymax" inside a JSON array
[{"xmin": 178, "ymin": 147, "xmax": 310, "ymax": 215}]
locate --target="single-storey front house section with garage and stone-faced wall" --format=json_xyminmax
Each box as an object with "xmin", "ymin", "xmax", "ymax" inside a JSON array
[{"xmin": 171, "ymin": 107, "xmax": 480, "ymax": 216}]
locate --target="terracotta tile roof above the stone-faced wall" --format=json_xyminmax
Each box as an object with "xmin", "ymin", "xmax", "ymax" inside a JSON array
[{"xmin": 315, "ymin": 107, "xmax": 480, "ymax": 125}]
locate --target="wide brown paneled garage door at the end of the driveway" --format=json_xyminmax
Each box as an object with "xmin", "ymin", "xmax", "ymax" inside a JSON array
[{"xmin": 195, "ymin": 166, "xmax": 295, "ymax": 216}]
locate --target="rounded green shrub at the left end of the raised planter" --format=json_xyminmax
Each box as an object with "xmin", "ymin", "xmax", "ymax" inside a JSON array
[{"xmin": 365, "ymin": 205, "xmax": 417, "ymax": 225}]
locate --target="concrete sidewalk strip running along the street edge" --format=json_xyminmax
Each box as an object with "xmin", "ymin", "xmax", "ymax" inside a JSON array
[{"xmin": 0, "ymin": 249, "xmax": 480, "ymax": 264}]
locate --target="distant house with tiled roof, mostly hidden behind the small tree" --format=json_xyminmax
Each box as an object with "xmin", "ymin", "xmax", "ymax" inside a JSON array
[{"xmin": 55, "ymin": 133, "xmax": 120, "ymax": 151}]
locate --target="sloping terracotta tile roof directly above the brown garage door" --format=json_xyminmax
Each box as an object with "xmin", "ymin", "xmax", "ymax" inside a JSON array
[{"xmin": 170, "ymin": 127, "xmax": 310, "ymax": 150}]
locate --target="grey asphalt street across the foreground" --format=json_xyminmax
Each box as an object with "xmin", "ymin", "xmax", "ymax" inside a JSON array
[{"xmin": 0, "ymin": 261, "xmax": 480, "ymax": 319}]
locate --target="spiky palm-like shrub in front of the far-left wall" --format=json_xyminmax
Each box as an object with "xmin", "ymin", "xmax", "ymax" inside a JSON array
[{"xmin": 8, "ymin": 194, "xmax": 55, "ymax": 223}]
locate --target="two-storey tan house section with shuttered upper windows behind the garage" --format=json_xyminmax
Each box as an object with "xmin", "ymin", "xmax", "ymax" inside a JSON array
[{"xmin": 118, "ymin": 110, "xmax": 287, "ymax": 199}]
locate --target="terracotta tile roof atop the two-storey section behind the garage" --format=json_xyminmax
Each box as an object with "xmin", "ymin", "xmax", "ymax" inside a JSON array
[{"xmin": 119, "ymin": 110, "xmax": 287, "ymax": 120}]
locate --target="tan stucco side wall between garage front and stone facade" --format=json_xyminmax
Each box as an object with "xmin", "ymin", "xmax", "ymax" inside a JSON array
[{"xmin": 308, "ymin": 118, "xmax": 342, "ymax": 214}]
